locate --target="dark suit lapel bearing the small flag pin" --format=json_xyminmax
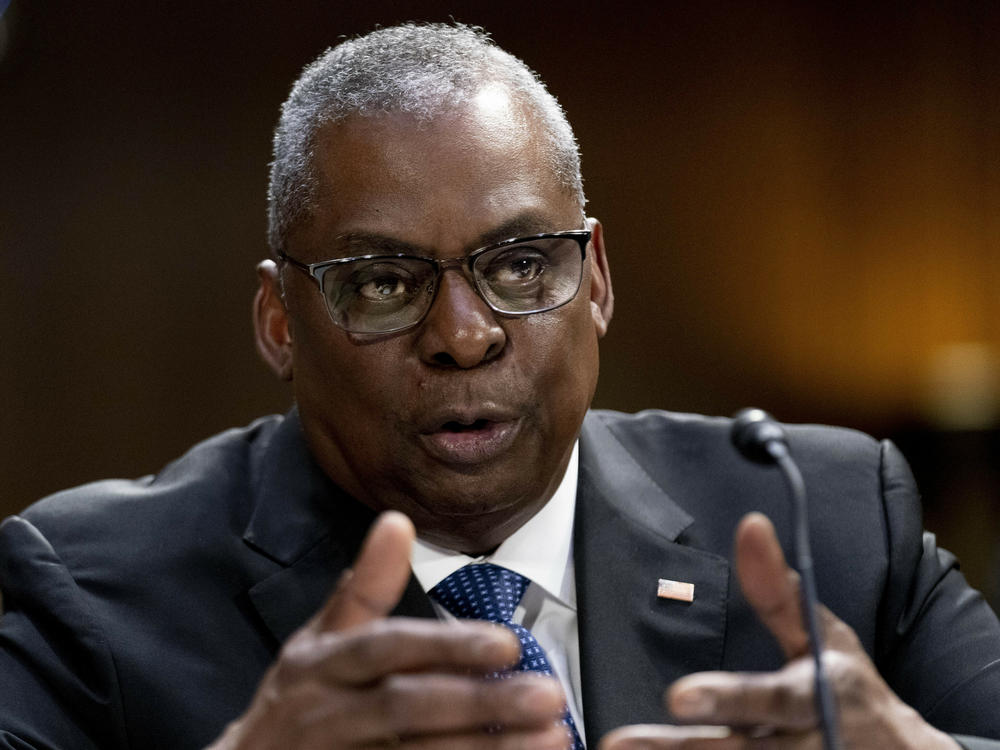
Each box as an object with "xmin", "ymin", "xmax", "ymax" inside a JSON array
[{"xmin": 574, "ymin": 415, "xmax": 729, "ymax": 746}]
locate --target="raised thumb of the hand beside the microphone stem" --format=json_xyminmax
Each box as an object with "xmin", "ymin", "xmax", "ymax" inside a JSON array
[{"xmin": 735, "ymin": 513, "xmax": 809, "ymax": 659}]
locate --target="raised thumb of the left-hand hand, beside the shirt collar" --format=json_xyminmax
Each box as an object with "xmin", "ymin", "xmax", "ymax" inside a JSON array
[{"xmin": 309, "ymin": 511, "xmax": 416, "ymax": 632}]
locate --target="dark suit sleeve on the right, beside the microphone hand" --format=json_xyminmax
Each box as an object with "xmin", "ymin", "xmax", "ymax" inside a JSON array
[{"xmin": 876, "ymin": 442, "xmax": 1000, "ymax": 750}]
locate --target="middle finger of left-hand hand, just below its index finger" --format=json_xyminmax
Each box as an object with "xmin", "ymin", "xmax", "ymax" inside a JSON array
[{"xmin": 298, "ymin": 673, "xmax": 566, "ymax": 746}]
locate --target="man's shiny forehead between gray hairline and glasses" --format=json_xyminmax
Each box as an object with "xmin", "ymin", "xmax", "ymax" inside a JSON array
[{"xmin": 294, "ymin": 93, "xmax": 581, "ymax": 258}]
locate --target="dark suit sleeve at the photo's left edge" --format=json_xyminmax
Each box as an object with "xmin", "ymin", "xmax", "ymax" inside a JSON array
[{"xmin": 0, "ymin": 517, "xmax": 126, "ymax": 750}]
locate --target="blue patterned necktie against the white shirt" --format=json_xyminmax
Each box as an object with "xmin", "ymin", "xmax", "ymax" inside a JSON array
[{"xmin": 430, "ymin": 563, "xmax": 585, "ymax": 750}]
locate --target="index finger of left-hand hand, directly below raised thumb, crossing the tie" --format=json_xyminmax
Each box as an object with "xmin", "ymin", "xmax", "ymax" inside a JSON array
[{"xmin": 278, "ymin": 617, "xmax": 521, "ymax": 685}]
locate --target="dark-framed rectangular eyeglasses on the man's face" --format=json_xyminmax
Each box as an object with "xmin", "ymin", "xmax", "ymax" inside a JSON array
[{"xmin": 278, "ymin": 229, "xmax": 590, "ymax": 333}]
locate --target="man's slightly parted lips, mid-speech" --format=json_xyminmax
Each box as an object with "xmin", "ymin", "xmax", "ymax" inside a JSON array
[{"xmin": 420, "ymin": 414, "xmax": 521, "ymax": 466}]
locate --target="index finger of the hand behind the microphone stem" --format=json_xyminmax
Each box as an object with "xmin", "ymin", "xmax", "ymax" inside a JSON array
[{"xmin": 667, "ymin": 658, "xmax": 817, "ymax": 732}]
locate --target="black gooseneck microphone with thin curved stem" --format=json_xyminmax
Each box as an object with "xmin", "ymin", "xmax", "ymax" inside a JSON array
[{"xmin": 729, "ymin": 409, "xmax": 841, "ymax": 750}]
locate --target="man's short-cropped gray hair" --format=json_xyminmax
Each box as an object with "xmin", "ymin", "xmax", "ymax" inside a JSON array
[{"xmin": 267, "ymin": 23, "xmax": 585, "ymax": 253}]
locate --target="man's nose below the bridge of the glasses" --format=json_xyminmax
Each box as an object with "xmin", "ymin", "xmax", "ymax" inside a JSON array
[{"xmin": 417, "ymin": 268, "xmax": 507, "ymax": 369}]
